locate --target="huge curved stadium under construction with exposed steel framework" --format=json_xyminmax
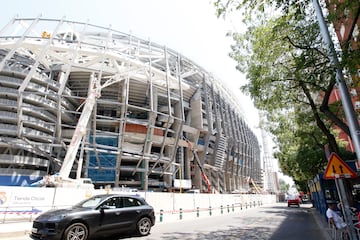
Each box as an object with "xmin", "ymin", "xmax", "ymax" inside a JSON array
[{"xmin": 0, "ymin": 18, "xmax": 263, "ymax": 193}]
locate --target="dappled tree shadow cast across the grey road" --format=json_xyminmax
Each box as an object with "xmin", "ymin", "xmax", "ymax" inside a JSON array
[{"xmin": 95, "ymin": 202, "xmax": 324, "ymax": 240}]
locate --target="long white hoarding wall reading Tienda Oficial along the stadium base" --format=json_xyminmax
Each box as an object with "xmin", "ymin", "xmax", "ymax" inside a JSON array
[{"xmin": 0, "ymin": 187, "xmax": 276, "ymax": 223}]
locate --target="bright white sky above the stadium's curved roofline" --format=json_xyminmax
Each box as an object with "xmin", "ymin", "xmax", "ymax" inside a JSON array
[{"xmin": 0, "ymin": 0, "xmax": 292, "ymax": 182}]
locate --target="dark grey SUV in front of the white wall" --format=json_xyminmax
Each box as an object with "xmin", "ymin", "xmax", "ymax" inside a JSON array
[{"xmin": 30, "ymin": 194, "xmax": 155, "ymax": 240}]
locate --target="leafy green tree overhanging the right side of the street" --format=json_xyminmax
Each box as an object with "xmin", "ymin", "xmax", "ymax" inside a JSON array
[{"xmin": 215, "ymin": 0, "xmax": 358, "ymax": 183}]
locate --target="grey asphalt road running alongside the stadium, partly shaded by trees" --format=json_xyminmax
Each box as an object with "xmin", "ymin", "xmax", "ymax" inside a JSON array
[{"xmin": 9, "ymin": 203, "xmax": 326, "ymax": 240}]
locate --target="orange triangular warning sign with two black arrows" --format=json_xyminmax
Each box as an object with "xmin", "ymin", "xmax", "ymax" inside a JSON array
[{"xmin": 323, "ymin": 153, "xmax": 357, "ymax": 179}]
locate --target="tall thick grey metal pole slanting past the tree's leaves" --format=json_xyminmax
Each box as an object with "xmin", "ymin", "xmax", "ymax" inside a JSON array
[{"xmin": 313, "ymin": 0, "xmax": 360, "ymax": 163}]
